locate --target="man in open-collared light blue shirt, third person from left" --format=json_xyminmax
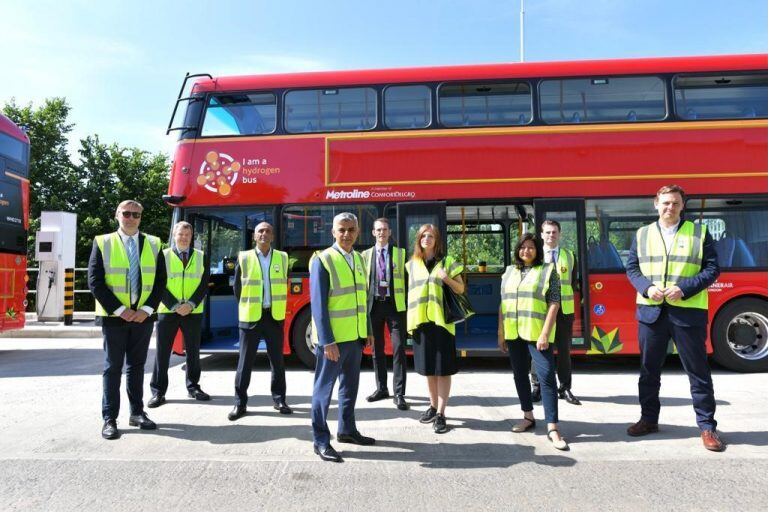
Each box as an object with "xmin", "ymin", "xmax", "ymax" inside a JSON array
[{"xmin": 228, "ymin": 222, "xmax": 293, "ymax": 421}]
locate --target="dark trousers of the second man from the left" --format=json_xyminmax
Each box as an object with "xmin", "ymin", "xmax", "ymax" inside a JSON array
[{"xmin": 149, "ymin": 313, "xmax": 203, "ymax": 395}]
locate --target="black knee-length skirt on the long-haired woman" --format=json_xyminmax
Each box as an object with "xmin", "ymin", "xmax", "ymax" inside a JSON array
[{"xmin": 413, "ymin": 322, "xmax": 459, "ymax": 377}]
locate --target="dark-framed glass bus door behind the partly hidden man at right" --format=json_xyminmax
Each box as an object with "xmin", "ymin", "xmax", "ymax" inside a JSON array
[{"xmin": 533, "ymin": 199, "xmax": 590, "ymax": 350}]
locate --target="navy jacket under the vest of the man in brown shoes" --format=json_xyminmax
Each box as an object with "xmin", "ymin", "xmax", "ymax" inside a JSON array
[{"xmin": 627, "ymin": 220, "xmax": 720, "ymax": 327}]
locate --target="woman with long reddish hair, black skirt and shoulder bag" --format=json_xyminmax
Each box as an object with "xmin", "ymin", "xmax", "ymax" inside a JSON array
[{"xmin": 406, "ymin": 224, "xmax": 464, "ymax": 434}]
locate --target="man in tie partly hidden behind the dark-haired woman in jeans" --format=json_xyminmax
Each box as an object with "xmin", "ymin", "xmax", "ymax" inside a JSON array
[{"xmin": 531, "ymin": 219, "xmax": 581, "ymax": 405}]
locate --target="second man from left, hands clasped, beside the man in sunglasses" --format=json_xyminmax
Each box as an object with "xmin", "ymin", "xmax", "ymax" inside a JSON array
[{"xmin": 147, "ymin": 220, "xmax": 211, "ymax": 408}]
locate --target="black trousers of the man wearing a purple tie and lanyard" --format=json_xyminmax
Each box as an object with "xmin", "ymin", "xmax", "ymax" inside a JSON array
[{"xmin": 371, "ymin": 297, "xmax": 407, "ymax": 395}]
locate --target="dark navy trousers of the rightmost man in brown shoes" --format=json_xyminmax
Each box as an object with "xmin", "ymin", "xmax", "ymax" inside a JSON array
[{"xmin": 638, "ymin": 307, "xmax": 717, "ymax": 430}]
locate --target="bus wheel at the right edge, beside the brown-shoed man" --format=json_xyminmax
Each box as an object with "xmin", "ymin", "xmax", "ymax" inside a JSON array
[{"xmin": 712, "ymin": 298, "xmax": 768, "ymax": 372}]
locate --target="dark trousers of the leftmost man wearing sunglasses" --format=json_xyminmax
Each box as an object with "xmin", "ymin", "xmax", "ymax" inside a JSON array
[{"xmin": 101, "ymin": 319, "xmax": 155, "ymax": 420}]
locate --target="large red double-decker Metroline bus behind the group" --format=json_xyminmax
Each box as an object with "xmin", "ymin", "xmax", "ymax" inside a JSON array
[{"xmin": 165, "ymin": 55, "xmax": 768, "ymax": 371}]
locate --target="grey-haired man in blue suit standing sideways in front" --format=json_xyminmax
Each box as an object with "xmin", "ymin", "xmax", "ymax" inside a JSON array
[{"xmin": 309, "ymin": 212, "xmax": 375, "ymax": 462}]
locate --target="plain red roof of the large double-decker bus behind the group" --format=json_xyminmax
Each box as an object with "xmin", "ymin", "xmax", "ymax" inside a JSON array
[{"xmin": 193, "ymin": 54, "xmax": 768, "ymax": 93}]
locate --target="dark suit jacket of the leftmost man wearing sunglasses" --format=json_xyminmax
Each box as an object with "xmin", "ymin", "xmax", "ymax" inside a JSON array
[{"xmin": 88, "ymin": 233, "xmax": 167, "ymax": 325}]
